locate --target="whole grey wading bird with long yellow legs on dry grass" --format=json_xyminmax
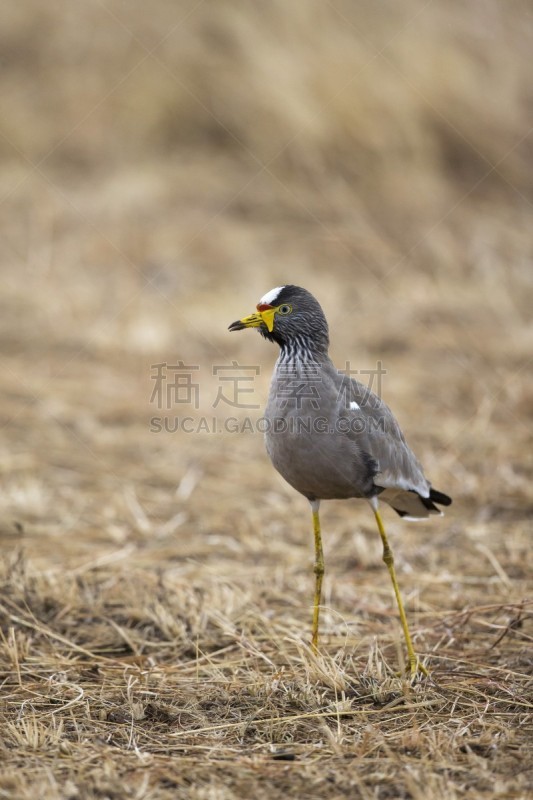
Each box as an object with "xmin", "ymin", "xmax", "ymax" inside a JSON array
[{"xmin": 229, "ymin": 284, "xmax": 452, "ymax": 678}]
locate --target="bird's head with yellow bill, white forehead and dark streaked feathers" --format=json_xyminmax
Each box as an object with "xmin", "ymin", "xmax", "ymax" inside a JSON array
[{"xmin": 229, "ymin": 285, "xmax": 329, "ymax": 351}]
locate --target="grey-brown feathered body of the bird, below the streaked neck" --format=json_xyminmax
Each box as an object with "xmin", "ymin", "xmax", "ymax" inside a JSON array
[{"xmin": 265, "ymin": 356, "xmax": 430, "ymax": 516}]
